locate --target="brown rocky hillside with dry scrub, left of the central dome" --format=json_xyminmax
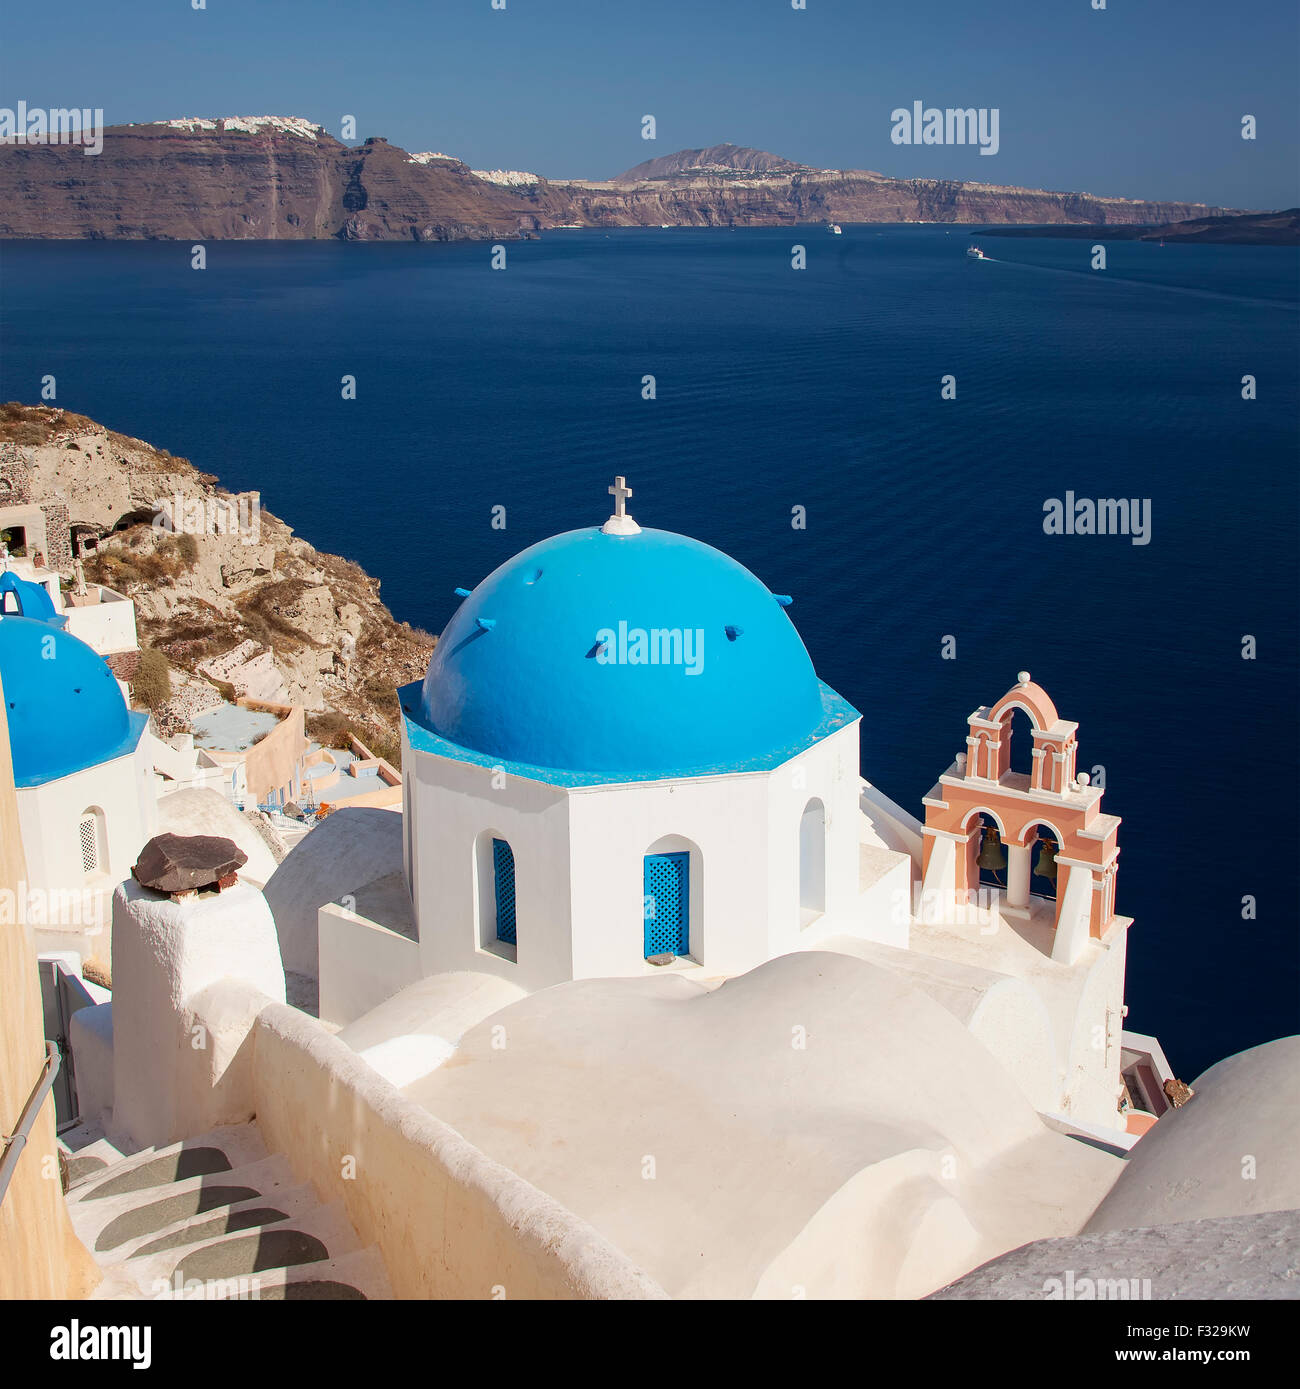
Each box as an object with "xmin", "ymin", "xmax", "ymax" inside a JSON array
[{"xmin": 0, "ymin": 403, "xmax": 433, "ymax": 761}]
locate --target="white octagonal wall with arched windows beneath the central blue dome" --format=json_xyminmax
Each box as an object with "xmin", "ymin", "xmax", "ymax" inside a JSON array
[{"xmin": 404, "ymin": 724, "xmax": 860, "ymax": 992}]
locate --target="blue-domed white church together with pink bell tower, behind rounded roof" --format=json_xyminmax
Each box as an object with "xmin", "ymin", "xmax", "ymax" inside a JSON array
[{"xmin": 291, "ymin": 478, "xmax": 1129, "ymax": 1140}]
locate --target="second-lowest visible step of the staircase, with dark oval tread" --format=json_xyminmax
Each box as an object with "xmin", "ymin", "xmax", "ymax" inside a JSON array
[{"xmin": 90, "ymin": 1203, "xmax": 360, "ymax": 1299}]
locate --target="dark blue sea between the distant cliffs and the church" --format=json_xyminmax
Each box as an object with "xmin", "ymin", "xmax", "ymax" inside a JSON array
[{"xmin": 0, "ymin": 226, "xmax": 1300, "ymax": 1079}]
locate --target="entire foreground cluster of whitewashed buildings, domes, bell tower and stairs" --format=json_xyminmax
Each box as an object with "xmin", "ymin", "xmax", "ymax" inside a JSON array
[{"xmin": 0, "ymin": 478, "xmax": 1300, "ymax": 1299}]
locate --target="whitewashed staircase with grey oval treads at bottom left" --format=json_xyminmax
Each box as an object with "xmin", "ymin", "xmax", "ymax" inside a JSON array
[{"xmin": 64, "ymin": 1124, "xmax": 393, "ymax": 1300}]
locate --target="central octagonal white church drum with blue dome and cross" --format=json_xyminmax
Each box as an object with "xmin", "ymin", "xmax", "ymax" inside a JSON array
[{"xmin": 400, "ymin": 479, "xmax": 860, "ymax": 990}]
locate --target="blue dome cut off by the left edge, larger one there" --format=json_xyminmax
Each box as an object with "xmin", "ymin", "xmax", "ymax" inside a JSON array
[{"xmin": 0, "ymin": 617, "xmax": 149, "ymax": 786}]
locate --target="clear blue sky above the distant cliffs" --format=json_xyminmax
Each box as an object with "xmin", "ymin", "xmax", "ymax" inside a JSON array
[{"xmin": 0, "ymin": 0, "xmax": 1300, "ymax": 208}]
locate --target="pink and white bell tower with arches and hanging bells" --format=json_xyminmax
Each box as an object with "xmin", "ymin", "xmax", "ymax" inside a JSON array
[{"xmin": 922, "ymin": 671, "xmax": 1126, "ymax": 964}]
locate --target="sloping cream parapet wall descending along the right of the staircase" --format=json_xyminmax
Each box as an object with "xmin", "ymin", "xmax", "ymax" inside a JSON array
[{"xmin": 253, "ymin": 1004, "xmax": 667, "ymax": 1300}]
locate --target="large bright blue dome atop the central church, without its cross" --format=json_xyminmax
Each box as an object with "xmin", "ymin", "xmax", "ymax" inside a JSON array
[{"xmin": 413, "ymin": 528, "xmax": 857, "ymax": 781}]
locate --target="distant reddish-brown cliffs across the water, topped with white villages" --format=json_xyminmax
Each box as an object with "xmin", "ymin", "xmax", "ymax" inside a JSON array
[{"xmin": 0, "ymin": 125, "xmax": 1225, "ymax": 242}]
